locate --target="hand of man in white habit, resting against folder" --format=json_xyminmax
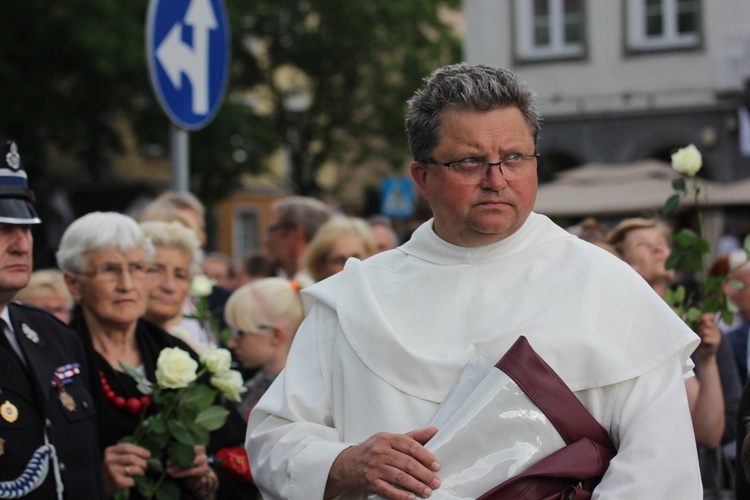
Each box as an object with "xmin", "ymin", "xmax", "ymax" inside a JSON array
[{"xmin": 324, "ymin": 427, "xmax": 440, "ymax": 500}]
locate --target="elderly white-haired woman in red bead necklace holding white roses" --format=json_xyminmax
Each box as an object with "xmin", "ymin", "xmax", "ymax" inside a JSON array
[{"xmin": 57, "ymin": 212, "xmax": 247, "ymax": 498}]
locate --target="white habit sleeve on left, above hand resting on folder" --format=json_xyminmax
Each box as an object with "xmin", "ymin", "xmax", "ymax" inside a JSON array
[{"xmin": 245, "ymin": 305, "xmax": 351, "ymax": 500}]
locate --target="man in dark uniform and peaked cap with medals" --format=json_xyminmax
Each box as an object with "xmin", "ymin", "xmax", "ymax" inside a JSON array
[{"xmin": 0, "ymin": 142, "xmax": 104, "ymax": 500}]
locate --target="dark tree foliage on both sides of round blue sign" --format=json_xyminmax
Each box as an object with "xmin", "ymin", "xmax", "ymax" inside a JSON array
[{"xmin": 0, "ymin": 0, "xmax": 459, "ymax": 205}]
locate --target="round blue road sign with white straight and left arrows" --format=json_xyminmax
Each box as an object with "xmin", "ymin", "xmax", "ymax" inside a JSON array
[{"xmin": 146, "ymin": 0, "xmax": 229, "ymax": 130}]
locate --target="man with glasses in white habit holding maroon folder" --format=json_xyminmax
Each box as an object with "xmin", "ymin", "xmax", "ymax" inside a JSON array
[{"xmin": 247, "ymin": 64, "xmax": 702, "ymax": 500}]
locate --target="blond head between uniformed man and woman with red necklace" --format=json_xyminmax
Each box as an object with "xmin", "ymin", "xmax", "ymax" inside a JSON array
[{"xmin": 13, "ymin": 269, "xmax": 73, "ymax": 323}]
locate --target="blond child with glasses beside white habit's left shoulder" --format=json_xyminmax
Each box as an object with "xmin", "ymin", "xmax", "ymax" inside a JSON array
[{"xmin": 224, "ymin": 278, "xmax": 304, "ymax": 420}]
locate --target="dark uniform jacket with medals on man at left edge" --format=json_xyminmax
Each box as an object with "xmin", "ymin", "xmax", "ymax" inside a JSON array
[{"xmin": 0, "ymin": 303, "xmax": 104, "ymax": 500}]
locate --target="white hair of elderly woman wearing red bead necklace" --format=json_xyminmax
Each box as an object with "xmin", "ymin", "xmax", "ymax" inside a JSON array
[{"xmin": 55, "ymin": 212, "xmax": 154, "ymax": 274}]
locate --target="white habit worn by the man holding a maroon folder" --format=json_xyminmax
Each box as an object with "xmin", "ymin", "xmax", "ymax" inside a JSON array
[{"xmin": 246, "ymin": 213, "xmax": 702, "ymax": 500}]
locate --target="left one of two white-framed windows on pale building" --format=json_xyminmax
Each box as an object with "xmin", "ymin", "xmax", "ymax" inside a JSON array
[{"xmin": 515, "ymin": 0, "xmax": 584, "ymax": 61}]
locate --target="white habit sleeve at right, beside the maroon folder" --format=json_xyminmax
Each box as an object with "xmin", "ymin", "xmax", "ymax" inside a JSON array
[{"xmin": 592, "ymin": 355, "xmax": 703, "ymax": 500}]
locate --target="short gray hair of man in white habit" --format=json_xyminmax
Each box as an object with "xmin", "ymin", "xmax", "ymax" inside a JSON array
[{"xmin": 406, "ymin": 63, "xmax": 541, "ymax": 162}]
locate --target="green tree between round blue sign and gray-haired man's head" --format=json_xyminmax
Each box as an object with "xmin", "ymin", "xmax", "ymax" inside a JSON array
[{"xmin": 244, "ymin": 0, "xmax": 460, "ymax": 194}]
